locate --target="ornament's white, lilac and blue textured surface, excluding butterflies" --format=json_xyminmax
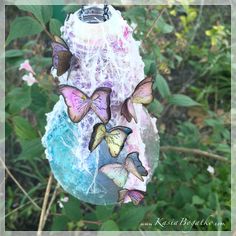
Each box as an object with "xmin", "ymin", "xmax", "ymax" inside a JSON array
[{"xmin": 42, "ymin": 6, "xmax": 159, "ymax": 205}]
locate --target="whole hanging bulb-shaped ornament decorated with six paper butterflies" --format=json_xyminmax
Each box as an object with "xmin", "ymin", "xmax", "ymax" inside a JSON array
[{"xmin": 42, "ymin": 5, "xmax": 159, "ymax": 205}]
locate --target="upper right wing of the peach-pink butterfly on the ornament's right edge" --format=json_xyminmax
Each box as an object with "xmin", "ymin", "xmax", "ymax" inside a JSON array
[{"xmin": 131, "ymin": 77, "xmax": 153, "ymax": 104}]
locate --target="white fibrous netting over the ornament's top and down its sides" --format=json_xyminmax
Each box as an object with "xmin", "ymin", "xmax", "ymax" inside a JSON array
[{"xmin": 46, "ymin": 6, "xmax": 158, "ymax": 202}]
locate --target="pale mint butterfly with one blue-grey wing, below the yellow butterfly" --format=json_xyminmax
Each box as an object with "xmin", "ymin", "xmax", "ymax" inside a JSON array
[{"xmin": 99, "ymin": 152, "xmax": 148, "ymax": 187}]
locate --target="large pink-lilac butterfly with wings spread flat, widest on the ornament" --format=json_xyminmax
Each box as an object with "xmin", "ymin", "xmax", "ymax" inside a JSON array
[{"xmin": 59, "ymin": 85, "xmax": 111, "ymax": 123}]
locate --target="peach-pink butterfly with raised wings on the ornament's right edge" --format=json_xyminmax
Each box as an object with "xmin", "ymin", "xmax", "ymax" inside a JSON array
[{"xmin": 121, "ymin": 77, "xmax": 153, "ymax": 123}]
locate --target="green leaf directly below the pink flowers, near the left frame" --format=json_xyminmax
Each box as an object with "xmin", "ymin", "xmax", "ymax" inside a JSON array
[{"xmin": 6, "ymin": 86, "xmax": 31, "ymax": 113}]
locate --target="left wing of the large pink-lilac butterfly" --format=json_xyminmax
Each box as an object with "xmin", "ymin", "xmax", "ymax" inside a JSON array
[{"xmin": 59, "ymin": 85, "xmax": 91, "ymax": 123}]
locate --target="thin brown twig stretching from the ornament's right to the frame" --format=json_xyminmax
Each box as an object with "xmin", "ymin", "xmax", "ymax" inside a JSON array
[{"xmin": 160, "ymin": 146, "xmax": 230, "ymax": 163}]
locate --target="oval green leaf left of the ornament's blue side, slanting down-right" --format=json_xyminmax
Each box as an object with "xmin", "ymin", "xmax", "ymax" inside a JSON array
[{"xmin": 12, "ymin": 116, "xmax": 37, "ymax": 140}]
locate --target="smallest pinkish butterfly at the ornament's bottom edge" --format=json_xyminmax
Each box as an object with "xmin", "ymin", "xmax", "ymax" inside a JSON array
[{"xmin": 118, "ymin": 189, "xmax": 144, "ymax": 205}]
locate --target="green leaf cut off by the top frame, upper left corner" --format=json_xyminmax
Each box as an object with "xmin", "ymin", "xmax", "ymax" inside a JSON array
[{"xmin": 17, "ymin": 5, "xmax": 52, "ymax": 24}]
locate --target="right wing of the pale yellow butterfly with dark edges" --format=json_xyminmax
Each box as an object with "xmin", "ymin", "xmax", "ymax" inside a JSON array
[{"xmin": 105, "ymin": 126, "xmax": 132, "ymax": 157}]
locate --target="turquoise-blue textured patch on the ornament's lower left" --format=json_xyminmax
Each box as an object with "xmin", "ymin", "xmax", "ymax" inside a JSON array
[{"xmin": 43, "ymin": 105, "xmax": 121, "ymax": 205}]
